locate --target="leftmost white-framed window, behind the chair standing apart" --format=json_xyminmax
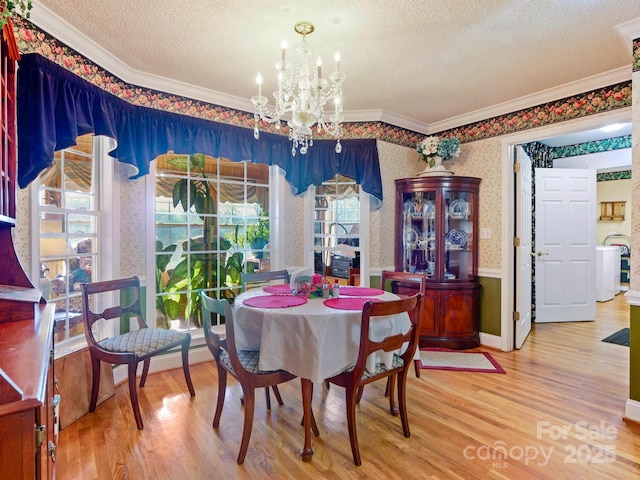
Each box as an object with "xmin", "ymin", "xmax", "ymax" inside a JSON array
[{"xmin": 32, "ymin": 135, "xmax": 117, "ymax": 353}]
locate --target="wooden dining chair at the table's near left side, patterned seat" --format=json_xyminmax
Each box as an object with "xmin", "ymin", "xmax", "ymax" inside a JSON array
[{"xmin": 200, "ymin": 292, "xmax": 296, "ymax": 465}]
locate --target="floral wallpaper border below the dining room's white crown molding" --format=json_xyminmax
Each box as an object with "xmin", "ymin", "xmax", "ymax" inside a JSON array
[{"xmin": 14, "ymin": 18, "xmax": 640, "ymax": 152}]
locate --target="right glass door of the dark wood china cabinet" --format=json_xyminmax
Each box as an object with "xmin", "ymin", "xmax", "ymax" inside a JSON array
[{"xmin": 443, "ymin": 191, "xmax": 476, "ymax": 281}]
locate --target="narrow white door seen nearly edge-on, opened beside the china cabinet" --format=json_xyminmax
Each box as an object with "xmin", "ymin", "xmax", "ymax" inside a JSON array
[{"xmin": 514, "ymin": 146, "xmax": 532, "ymax": 348}]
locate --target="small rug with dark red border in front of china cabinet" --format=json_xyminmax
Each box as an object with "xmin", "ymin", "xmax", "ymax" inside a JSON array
[{"xmin": 420, "ymin": 348, "xmax": 507, "ymax": 373}]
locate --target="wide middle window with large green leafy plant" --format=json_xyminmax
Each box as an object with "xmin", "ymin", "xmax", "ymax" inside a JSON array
[{"xmin": 154, "ymin": 154, "xmax": 270, "ymax": 330}]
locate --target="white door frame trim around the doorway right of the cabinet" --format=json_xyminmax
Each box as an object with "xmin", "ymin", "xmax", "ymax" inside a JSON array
[{"xmin": 500, "ymin": 108, "xmax": 631, "ymax": 351}]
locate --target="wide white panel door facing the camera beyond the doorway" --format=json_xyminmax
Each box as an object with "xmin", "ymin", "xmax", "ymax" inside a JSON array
[{"xmin": 535, "ymin": 168, "xmax": 596, "ymax": 323}]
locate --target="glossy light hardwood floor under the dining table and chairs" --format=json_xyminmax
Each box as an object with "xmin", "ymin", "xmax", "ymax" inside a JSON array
[{"xmin": 56, "ymin": 295, "xmax": 640, "ymax": 480}]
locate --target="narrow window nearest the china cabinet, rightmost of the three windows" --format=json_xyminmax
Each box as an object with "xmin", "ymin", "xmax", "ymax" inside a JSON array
[{"xmin": 312, "ymin": 175, "xmax": 366, "ymax": 279}]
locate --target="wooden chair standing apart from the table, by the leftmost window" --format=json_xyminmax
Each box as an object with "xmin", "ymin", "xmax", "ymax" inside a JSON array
[{"xmin": 81, "ymin": 277, "xmax": 196, "ymax": 430}]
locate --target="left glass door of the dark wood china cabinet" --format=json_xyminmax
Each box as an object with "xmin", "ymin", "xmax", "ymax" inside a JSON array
[{"xmin": 402, "ymin": 191, "xmax": 437, "ymax": 278}]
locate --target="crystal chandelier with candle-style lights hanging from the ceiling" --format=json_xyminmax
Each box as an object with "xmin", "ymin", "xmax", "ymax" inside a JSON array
[{"xmin": 251, "ymin": 21, "xmax": 347, "ymax": 157}]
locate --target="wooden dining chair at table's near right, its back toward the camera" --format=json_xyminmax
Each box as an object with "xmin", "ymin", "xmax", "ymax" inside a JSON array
[{"xmin": 327, "ymin": 293, "xmax": 422, "ymax": 465}]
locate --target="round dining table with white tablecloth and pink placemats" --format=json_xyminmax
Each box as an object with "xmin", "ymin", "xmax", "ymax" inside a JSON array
[{"xmin": 234, "ymin": 284, "xmax": 417, "ymax": 461}]
